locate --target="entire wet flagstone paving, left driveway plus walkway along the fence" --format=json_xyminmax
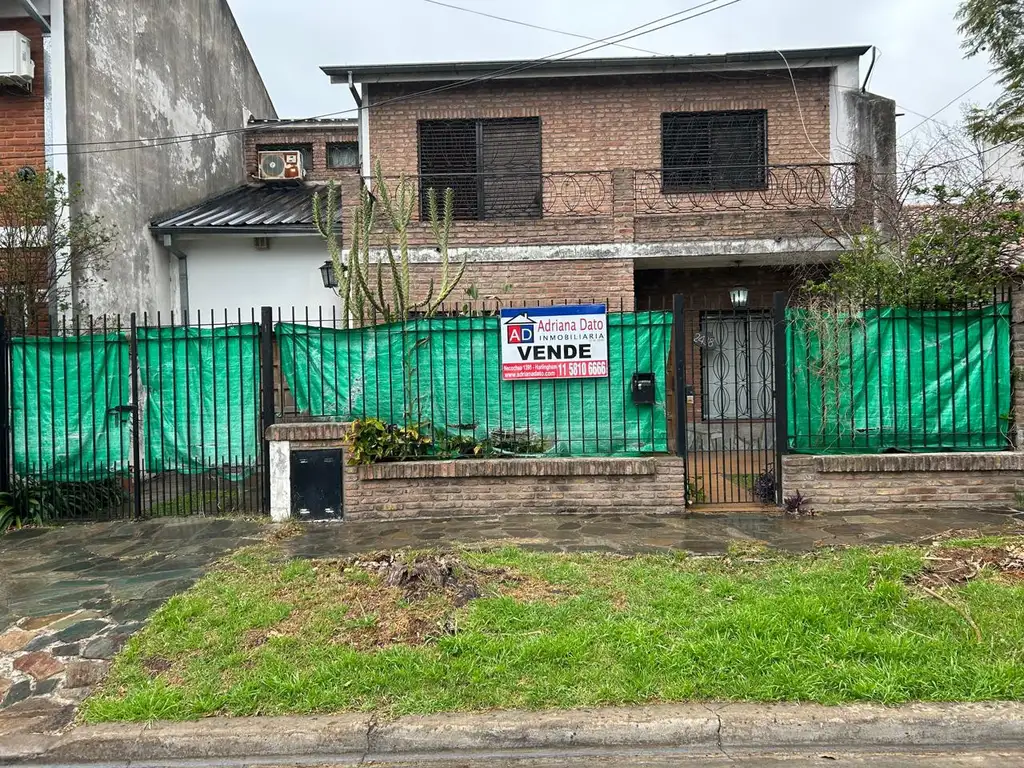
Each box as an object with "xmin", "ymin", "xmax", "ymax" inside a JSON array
[{"xmin": 0, "ymin": 510, "xmax": 1024, "ymax": 739}]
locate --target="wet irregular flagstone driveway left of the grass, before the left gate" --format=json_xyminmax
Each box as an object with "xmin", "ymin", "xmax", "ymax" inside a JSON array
[{"xmin": 0, "ymin": 518, "xmax": 265, "ymax": 738}]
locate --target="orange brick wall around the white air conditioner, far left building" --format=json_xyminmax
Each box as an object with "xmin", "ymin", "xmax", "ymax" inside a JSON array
[{"xmin": 0, "ymin": 18, "xmax": 46, "ymax": 173}]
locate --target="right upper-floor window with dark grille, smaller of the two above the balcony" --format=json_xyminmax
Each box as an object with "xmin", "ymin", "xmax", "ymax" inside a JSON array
[{"xmin": 662, "ymin": 110, "xmax": 768, "ymax": 193}]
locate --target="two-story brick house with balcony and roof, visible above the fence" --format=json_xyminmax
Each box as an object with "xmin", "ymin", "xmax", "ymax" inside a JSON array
[{"xmin": 325, "ymin": 47, "xmax": 895, "ymax": 304}]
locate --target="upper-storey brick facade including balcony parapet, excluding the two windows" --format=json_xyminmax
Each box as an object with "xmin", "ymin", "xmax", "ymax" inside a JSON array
[{"xmin": 370, "ymin": 70, "xmax": 830, "ymax": 246}]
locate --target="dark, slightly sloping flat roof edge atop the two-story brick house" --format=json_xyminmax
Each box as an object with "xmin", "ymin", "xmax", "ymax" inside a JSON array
[{"xmin": 321, "ymin": 45, "xmax": 871, "ymax": 83}]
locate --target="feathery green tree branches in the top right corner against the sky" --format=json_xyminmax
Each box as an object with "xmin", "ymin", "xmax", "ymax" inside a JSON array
[{"xmin": 956, "ymin": 0, "xmax": 1024, "ymax": 144}]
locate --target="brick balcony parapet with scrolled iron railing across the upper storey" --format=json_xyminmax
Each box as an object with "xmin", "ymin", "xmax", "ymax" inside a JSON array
[{"xmin": 372, "ymin": 163, "xmax": 869, "ymax": 246}]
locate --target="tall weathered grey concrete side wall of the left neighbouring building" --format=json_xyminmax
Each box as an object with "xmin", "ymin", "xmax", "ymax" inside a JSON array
[{"xmin": 65, "ymin": 0, "xmax": 276, "ymax": 312}]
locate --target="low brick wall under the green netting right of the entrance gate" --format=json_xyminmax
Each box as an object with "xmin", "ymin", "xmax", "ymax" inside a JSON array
[{"xmin": 782, "ymin": 453, "xmax": 1024, "ymax": 513}]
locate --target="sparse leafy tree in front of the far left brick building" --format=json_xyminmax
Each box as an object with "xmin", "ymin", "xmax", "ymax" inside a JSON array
[{"xmin": 0, "ymin": 169, "xmax": 114, "ymax": 333}]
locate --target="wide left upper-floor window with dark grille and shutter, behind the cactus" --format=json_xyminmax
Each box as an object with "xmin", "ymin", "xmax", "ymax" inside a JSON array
[{"xmin": 417, "ymin": 116, "xmax": 544, "ymax": 221}]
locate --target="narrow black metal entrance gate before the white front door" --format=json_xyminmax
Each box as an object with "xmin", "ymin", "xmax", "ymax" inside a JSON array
[{"xmin": 672, "ymin": 292, "xmax": 785, "ymax": 505}]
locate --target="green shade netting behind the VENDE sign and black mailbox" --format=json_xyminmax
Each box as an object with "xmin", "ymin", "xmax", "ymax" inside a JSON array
[{"xmin": 276, "ymin": 312, "xmax": 672, "ymax": 456}]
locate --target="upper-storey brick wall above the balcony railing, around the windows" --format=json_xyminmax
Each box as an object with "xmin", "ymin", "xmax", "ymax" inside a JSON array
[{"xmin": 370, "ymin": 70, "xmax": 829, "ymax": 175}]
